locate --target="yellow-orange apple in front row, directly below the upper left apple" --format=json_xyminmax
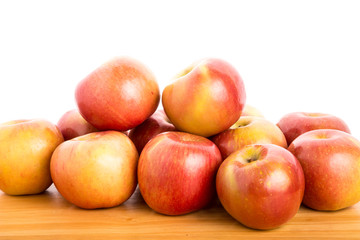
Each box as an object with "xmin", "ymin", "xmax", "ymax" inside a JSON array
[{"xmin": 50, "ymin": 131, "xmax": 138, "ymax": 209}]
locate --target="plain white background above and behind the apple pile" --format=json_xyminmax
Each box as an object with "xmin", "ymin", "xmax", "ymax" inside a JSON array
[{"xmin": 0, "ymin": 0, "xmax": 360, "ymax": 138}]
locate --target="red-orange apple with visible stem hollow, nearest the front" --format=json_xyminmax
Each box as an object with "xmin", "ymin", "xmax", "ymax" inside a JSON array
[{"xmin": 216, "ymin": 144, "xmax": 305, "ymax": 230}]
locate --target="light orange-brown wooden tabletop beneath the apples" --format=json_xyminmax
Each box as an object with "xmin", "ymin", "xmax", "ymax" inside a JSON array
[{"xmin": 0, "ymin": 186, "xmax": 360, "ymax": 240}]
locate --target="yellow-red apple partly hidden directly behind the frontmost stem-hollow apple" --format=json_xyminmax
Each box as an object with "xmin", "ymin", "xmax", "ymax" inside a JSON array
[{"xmin": 211, "ymin": 116, "xmax": 287, "ymax": 159}]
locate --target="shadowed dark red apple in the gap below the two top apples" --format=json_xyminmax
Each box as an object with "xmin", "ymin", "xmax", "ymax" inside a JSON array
[{"xmin": 129, "ymin": 109, "xmax": 175, "ymax": 153}]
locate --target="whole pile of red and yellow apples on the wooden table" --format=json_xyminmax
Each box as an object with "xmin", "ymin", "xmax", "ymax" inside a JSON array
[{"xmin": 0, "ymin": 58, "xmax": 360, "ymax": 229}]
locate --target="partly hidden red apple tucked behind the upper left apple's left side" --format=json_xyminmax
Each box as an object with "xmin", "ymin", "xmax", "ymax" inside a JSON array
[{"xmin": 57, "ymin": 109, "xmax": 98, "ymax": 141}]
